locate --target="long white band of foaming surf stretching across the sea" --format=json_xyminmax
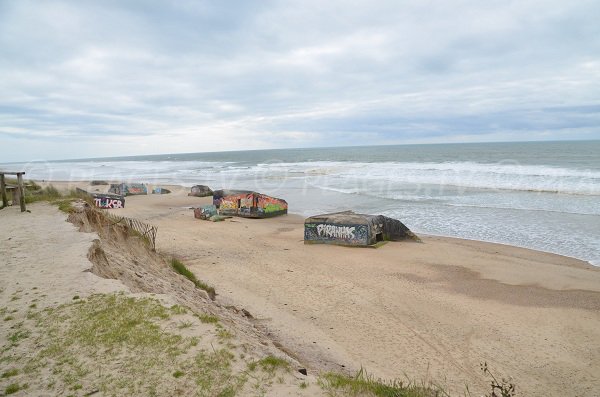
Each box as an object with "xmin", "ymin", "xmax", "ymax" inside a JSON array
[{"xmin": 15, "ymin": 161, "xmax": 600, "ymax": 195}]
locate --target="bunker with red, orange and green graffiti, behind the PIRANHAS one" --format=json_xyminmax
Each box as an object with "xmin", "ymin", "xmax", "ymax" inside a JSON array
[{"xmin": 213, "ymin": 190, "xmax": 287, "ymax": 218}]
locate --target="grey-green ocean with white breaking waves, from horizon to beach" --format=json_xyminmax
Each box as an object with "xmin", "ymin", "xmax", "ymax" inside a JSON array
[{"xmin": 2, "ymin": 141, "xmax": 600, "ymax": 266}]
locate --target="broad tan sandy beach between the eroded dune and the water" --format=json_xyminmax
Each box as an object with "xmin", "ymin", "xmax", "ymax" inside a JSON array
[{"xmin": 4, "ymin": 181, "xmax": 600, "ymax": 396}]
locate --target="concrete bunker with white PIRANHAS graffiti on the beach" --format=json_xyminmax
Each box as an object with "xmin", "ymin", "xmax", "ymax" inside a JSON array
[{"xmin": 304, "ymin": 211, "xmax": 417, "ymax": 246}]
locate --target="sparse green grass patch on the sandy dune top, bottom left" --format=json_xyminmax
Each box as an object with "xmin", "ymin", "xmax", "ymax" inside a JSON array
[{"xmin": 5, "ymin": 294, "xmax": 247, "ymax": 397}]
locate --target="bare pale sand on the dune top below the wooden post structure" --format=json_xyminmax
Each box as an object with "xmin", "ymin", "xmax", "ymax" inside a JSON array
[{"xmin": 0, "ymin": 203, "xmax": 127, "ymax": 306}]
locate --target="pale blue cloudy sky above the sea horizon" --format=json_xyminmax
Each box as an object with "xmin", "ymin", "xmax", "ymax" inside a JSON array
[{"xmin": 0, "ymin": 0, "xmax": 600, "ymax": 163}]
